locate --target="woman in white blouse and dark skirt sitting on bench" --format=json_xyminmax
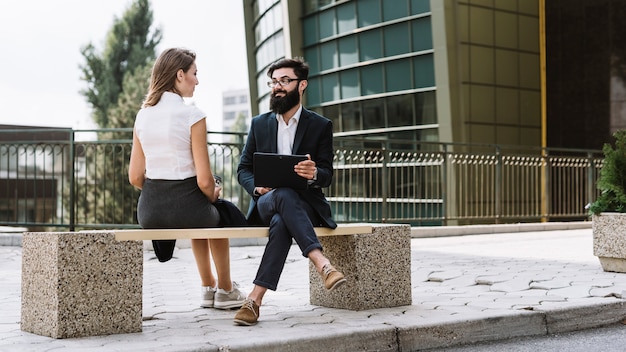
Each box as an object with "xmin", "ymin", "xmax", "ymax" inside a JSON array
[{"xmin": 128, "ymin": 48, "xmax": 246, "ymax": 309}]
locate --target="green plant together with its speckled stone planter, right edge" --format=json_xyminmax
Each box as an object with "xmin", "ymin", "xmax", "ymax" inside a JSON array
[{"xmin": 589, "ymin": 130, "xmax": 626, "ymax": 273}]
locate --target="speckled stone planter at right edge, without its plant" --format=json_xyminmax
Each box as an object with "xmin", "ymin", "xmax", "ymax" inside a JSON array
[{"xmin": 592, "ymin": 213, "xmax": 626, "ymax": 273}]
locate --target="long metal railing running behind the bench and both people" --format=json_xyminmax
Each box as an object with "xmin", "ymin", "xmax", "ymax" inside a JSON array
[{"xmin": 0, "ymin": 129, "xmax": 603, "ymax": 231}]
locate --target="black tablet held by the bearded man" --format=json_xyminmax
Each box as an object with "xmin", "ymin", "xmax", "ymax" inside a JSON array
[{"xmin": 253, "ymin": 152, "xmax": 308, "ymax": 189}]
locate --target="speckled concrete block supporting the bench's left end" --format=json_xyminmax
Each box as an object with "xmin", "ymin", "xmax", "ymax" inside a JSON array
[{"xmin": 21, "ymin": 232, "xmax": 143, "ymax": 338}]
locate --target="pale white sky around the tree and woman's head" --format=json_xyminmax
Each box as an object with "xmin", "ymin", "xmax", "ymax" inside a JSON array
[{"xmin": 0, "ymin": 0, "xmax": 248, "ymax": 131}]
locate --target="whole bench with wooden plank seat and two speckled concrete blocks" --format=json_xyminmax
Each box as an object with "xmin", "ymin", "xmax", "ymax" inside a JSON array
[{"xmin": 21, "ymin": 224, "xmax": 412, "ymax": 338}]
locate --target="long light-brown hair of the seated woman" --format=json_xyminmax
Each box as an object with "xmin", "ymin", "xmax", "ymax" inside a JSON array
[{"xmin": 143, "ymin": 48, "xmax": 196, "ymax": 107}]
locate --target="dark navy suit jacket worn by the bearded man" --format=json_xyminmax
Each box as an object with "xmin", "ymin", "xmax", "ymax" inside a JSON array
[{"xmin": 237, "ymin": 108, "xmax": 337, "ymax": 228}]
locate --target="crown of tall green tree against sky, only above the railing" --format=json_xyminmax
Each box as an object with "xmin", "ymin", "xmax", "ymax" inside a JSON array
[{"xmin": 80, "ymin": 0, "xmax": 162, "ymax": 128}]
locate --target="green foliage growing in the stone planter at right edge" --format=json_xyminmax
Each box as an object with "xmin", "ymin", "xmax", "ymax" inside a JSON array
[{"xmin": 589, "ymin": 130, "xmax": 626, "ymax": 214}]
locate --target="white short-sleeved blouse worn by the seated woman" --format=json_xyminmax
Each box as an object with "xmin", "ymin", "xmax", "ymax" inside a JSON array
[{"xmin": 135, "ymin": 92, "xmax": 206, "ymax": 180}]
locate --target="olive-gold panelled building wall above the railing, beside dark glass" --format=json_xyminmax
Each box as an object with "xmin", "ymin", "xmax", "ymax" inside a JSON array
[{"xmin": 431, "ymin": 0, "xmax": 541, "ymax": 146}]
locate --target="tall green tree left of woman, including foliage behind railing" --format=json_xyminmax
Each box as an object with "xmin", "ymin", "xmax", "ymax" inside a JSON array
[{"xmin": 75, "ymin": 0, "xmax": 161, "ymax": 224}]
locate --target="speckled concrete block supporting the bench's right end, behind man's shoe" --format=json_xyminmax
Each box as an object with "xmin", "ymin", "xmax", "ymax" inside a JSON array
[{"xmin": 309, "ymin": 224, "xmax": 412, "ymax": 311}]
